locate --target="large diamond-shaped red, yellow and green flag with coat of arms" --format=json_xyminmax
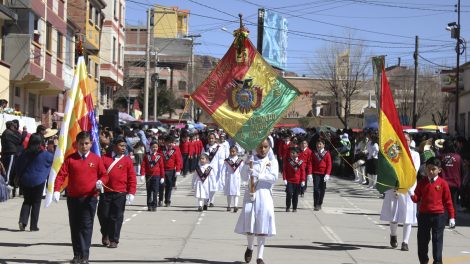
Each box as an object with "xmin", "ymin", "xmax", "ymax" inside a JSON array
[{"xmin": 191, "ymin": 29, "xmax": 300, "ymax": 150}]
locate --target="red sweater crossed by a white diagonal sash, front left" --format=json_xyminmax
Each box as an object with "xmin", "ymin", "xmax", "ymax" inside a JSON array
[{"xmin": 101, "ymin": 153, "xmax": 136, "ymax": 194}]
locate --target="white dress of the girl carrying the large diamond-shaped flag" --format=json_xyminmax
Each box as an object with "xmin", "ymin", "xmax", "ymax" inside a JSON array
[{"xmin": 235, "ymin": 156, "xmax": 279, "ymax": 236}]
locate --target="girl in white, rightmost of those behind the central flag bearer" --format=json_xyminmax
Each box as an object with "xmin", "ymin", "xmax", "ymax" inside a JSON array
[{"xmin": 220, "ymin": 146, "xmax": 243, "ymax": 213}]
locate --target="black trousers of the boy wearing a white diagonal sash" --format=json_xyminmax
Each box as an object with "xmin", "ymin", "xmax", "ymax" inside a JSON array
[{"xmin": 98, "ymin": 192, "xmax": 126, "ymax": 243}]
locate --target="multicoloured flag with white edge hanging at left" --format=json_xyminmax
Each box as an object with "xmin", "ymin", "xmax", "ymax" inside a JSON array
[{"xmin": 45, "ymin": 56, "xmax": 100, "ymax": 207}]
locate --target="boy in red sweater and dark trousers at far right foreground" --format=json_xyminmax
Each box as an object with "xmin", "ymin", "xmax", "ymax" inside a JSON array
[{"xmin": 408, "ymin": 157, "xmax": 455, "ymax": 264}]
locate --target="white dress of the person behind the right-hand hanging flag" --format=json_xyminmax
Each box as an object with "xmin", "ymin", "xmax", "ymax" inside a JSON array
[{"xmin": 380, "ymin": 150, "xmax": 421, "ymax": 224}]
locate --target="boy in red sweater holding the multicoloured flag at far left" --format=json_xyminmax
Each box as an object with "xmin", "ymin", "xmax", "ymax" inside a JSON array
[{"xmin": 52, "ymin": 131, "xmax": 108, "ymax": 263}]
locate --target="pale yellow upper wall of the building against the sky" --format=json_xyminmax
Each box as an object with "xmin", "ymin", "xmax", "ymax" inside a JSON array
[{"xmin": 153, "ymin": 6, "xmax": 189, "ymax": 38}]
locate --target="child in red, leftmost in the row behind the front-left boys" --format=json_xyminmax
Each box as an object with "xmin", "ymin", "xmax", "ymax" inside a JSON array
[{"xmin": 140, "ymin": 141, "xmax": 165, "ymax": 212}]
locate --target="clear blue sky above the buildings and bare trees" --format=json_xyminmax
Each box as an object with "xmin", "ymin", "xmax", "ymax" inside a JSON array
[{"xmin": 126, "ymin": 0, "xmax": 470, "ymax": 75}]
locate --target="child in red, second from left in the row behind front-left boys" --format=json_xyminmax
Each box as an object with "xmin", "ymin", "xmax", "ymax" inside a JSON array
[{"xmin": 159, "ymin": 135, "xmax": 183, "ymax": 207}]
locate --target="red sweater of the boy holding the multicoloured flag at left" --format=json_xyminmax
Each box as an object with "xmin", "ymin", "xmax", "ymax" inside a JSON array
[{"xmin": 54, "ymin": 152, "xmax": 108, "ymax": 197}]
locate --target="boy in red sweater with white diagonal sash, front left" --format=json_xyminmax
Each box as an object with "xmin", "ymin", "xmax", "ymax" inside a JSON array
[{"xmin": 98, "ymin": 137, "xmax": 136, "ymax": 248}]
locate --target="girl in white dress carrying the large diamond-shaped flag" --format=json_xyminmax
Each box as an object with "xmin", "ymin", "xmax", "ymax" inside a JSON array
[{"xmin": 235, "ymin": 139, "xmax": 279, "ymax": 264}]
